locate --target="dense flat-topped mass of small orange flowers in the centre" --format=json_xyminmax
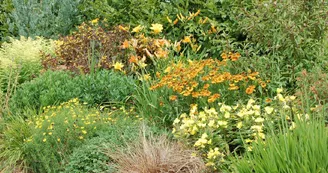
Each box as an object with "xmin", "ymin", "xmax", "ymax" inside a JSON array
[{"xmin": 150, "ymin": 55, "xmax": 262, "ymax": 103}]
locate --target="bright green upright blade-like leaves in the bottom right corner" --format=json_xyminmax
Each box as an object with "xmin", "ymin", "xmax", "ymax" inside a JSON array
[{"xmin": 229, "ymin": 112, "xmax": 328, "ymax": 173}]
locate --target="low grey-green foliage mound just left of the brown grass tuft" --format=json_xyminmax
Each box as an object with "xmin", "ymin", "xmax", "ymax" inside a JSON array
[{"xmin": 64, "ymin": 118, "xmax": 139, "ymax": 173}]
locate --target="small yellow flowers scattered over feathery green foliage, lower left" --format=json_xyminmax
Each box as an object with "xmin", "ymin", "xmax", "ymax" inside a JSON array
[{"xmin": 26, "ymin": 98, "xmax": 115, "ymax": 143}]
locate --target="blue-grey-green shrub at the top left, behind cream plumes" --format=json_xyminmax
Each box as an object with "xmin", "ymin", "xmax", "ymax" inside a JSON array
[{"xmin": 11, "ymin": 0, "xmax": 80, "ymax": 38}]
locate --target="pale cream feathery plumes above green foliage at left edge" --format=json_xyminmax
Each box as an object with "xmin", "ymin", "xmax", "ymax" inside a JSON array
[{"xmin": 0, "ymin": 36, "xmax": 55, "ymax": 86}]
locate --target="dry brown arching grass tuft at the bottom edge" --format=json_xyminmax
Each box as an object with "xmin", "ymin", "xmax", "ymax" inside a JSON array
[{"xmin": 108, "ymin": 133, "xmax": 205, "ymax": 173}]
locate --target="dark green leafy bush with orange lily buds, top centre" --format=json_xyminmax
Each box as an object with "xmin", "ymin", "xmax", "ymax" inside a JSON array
[{"xmin": 164, "ymin": 9, "xmax": 232, "ymax": 58}]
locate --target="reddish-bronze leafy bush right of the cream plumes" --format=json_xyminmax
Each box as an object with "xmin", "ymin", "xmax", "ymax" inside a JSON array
[{"xmin": 43, "ymin": 19, "xmax": 129, "ymax": 74}]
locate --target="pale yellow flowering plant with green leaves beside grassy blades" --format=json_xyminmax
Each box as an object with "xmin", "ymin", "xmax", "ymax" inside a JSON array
[{"xmin": 172, "ymin": 89, "xmax": 300, "ymax": 170}]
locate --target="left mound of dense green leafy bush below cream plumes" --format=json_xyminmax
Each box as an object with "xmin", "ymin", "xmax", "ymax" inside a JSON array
[{"xmin": 10, "ymin": 71, "xmax": 76, "ymax": 113}]
